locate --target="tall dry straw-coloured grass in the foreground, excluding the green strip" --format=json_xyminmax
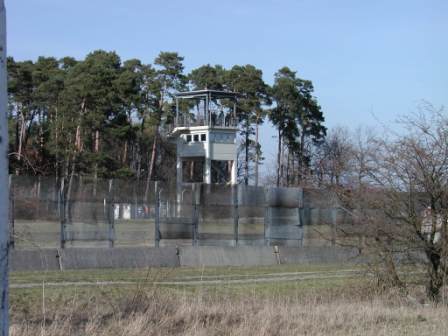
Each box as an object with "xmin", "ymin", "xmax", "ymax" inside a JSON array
[{"xmin": 11, "ymin": 285, "xmax": 448, "ymax": 336}]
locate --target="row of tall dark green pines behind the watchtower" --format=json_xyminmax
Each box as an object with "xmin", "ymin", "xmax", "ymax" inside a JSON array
[{"xmin": 7, "ymin": 50, "xmax": 326, "ymax": 185}]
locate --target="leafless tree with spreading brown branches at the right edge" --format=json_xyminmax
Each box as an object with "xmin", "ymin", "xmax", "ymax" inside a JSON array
[{"xmin": 337, "ymin": 103, "xmax": 448, "ymax": 301}]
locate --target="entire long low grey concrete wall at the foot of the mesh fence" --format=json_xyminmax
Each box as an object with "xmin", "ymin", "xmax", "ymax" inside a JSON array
[{"xmin": 10, "ymin": 246, "xmax": 362, "ymax": 271}]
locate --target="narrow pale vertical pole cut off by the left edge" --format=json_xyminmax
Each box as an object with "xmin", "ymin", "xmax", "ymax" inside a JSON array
[{"xmin": 0, "ymin": 0, "xmax": 9, "ymax": 336}]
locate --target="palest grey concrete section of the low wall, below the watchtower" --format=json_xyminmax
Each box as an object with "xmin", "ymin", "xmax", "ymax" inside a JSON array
[{"xmin": 180, "ymin": 246, "xmax": 277, "ymax": 266}]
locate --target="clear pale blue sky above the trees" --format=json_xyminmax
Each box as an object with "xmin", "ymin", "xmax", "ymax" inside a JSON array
[{"xmin": 6, "ymin": 0, "xmax": 448, "ymax": 173}]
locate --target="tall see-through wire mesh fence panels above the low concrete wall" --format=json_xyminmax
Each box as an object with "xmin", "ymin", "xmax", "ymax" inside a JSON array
[{"xmin": 10, "ymin": 176, "xmax": 350, "ymax": 248}]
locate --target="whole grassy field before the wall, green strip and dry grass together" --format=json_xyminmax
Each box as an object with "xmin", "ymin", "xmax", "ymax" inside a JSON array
[{"xmin": 10, "ymin": 265, "xmax": 448, "ymax": 336}]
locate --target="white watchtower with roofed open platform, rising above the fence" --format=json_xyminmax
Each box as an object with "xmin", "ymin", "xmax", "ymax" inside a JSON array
[{"xmin": 170, "ymin": 89, "xmax": 238, "ymax": 186}]
